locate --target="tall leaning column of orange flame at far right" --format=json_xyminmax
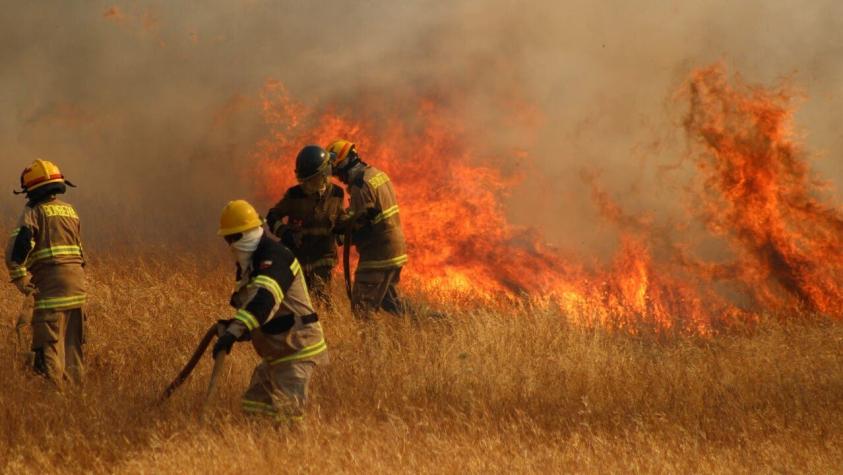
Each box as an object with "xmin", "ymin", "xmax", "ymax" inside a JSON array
[{"xmin": 685, "ymin": 66, "xmax": 843, "ymax": 317}]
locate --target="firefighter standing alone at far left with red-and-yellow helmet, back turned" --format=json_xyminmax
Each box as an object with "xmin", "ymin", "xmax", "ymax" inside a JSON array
[{"xmin": 6, "ymin": 160, "xmax": 86, "ymax": 388}]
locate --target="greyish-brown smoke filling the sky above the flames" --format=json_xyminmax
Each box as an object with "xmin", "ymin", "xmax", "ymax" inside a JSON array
[{"xmin": 0, "ymin": 0, "xmax": 843, "ymax": 252}]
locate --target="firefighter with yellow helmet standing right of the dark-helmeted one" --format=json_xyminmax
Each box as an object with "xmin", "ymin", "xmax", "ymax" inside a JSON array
[{"xmin": 327, "ymin": 140, "xmax": 407, "ymax": 316}]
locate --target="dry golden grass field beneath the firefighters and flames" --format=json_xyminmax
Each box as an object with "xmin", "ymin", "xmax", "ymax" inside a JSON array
[{"xmin": 0, "ymin": 252, "xmax": 843, "ymax": 473}]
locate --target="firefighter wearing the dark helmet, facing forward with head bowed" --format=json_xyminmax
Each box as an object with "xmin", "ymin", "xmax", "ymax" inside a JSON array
[{"xmin": 266, "ymin": 145, "xmax": 345, "ymax": 300}]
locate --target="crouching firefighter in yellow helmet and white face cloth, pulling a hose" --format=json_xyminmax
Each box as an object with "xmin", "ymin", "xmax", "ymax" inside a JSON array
[{"xmin": 213, "ymin": 200, "xmax": 327, "ymax": 422}]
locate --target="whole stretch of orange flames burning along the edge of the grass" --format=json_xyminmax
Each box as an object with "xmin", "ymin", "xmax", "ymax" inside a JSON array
[{"xmin": 256, "ymin": 66, "xmax": 843, "ymax": 334}]
